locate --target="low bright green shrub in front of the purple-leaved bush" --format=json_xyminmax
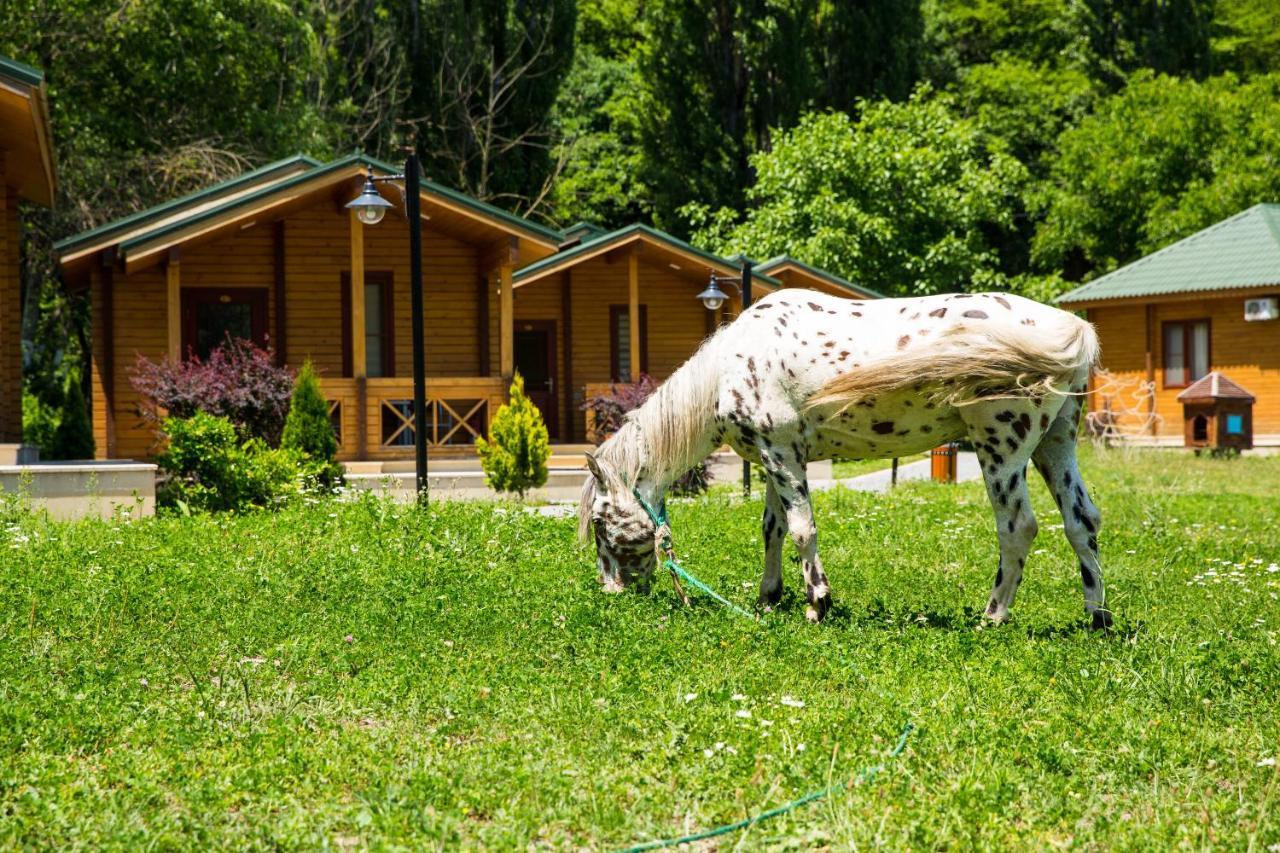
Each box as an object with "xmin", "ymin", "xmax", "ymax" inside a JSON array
[{"xmin": 156, "ymin": 411, "xmax": 306, "ymax": 511}]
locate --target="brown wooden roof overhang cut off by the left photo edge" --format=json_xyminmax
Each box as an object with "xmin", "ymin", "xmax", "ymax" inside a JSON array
[{"xmin": 0, "ymin": 56, "xmax": 58, "ymax": 207}]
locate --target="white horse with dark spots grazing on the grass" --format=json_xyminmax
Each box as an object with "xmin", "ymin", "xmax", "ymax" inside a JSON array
[{"xmin": 579, "ymin": 289, "xmax": 1110, "ymax": 628}]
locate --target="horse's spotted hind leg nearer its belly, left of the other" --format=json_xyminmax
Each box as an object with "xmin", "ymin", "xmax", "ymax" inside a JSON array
[{"xmin": 961, "ymin": 400, "xmax": 1043, "ymax": 622}]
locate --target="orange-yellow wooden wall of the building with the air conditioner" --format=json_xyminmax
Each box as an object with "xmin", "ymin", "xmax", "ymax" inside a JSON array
[{"xmin": 1089, "ymin": 293, "xmax": 1280, "ymax": 442}]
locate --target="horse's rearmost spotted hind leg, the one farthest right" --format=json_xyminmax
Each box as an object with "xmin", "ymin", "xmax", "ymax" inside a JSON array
[{"xmin": 1032, "ymin": 398, "xmax": 1111, "ymax": 629}]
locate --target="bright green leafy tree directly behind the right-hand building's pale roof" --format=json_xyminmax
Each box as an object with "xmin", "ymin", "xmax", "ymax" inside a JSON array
[{"xmin": 1033, "ymin": 73, "xmax": 1280, "ymax": 279}]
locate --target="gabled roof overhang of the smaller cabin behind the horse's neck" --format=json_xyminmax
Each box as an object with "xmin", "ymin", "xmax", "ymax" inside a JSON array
[{"xmin": 515, "ymin": 224, "xmax": 781, "ymax": 289}]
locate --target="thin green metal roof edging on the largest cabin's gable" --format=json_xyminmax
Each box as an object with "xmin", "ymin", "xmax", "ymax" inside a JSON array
[{"xmin": 54, "ymin": 151, "xmax": 563, "ymax": 256}]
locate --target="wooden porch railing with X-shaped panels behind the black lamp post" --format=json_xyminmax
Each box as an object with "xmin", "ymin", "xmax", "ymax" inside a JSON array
[{"xmin": 320, "ymin": 377, "xmax": 507, "ymax": 460}]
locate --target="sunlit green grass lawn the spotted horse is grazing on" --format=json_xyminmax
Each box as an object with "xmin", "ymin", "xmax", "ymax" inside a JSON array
[{"xmin": 0, "ymin": 452, "xmax": 1280, "ymax": 850}]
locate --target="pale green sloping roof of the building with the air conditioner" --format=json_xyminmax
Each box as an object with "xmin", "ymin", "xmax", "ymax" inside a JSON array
[{"xmin": 1057, "ymin": 204, "xmax": 1280, "ymax": 305}]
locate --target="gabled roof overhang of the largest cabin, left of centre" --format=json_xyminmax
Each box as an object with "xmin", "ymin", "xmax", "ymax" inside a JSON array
[{"xmin": 60, "ymin": 154, "xmax": 562, "ymax": 279}]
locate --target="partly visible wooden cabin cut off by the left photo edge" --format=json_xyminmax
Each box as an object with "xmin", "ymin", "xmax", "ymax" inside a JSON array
[{"xmin": 0, "ymin": 56, "xmax": 56, "ymax": 450}]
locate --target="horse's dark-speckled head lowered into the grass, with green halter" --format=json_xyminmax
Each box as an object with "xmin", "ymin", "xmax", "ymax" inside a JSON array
[{"xmin": 579, "ymin": 453, "xmax": 658, "ymax": 592}]
